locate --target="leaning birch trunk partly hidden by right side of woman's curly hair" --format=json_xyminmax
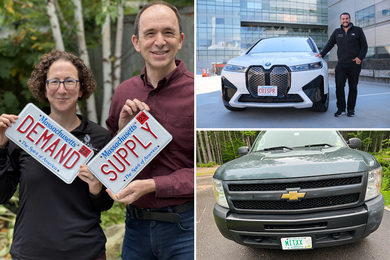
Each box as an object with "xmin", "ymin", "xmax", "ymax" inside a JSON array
[{"xmin": 73, "ymin": 0, "xmax": 98, "ymax": 123}]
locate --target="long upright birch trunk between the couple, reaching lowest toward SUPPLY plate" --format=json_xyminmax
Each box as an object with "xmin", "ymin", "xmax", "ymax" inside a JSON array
[{"xmin": 100, "ymin": 0, "xmax": 112, "ymax": 127}]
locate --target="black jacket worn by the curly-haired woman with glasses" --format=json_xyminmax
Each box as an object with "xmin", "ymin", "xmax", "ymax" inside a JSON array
[{"xmin": 0, "ymin": 111, "xmax": 113, "ymax": 260}]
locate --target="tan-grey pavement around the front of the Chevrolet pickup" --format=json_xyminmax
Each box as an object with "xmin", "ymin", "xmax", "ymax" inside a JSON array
[{"xmin": 196, "ymin": 175, "xmax": 390, "ymax": 260}]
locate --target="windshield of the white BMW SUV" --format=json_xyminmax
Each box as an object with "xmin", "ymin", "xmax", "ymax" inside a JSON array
[{"xmin": 248, "ymin": 37, "xmax": 315, "ymax": 54}]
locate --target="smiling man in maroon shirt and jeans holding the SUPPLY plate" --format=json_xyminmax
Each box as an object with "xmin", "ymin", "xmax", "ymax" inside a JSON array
[{"xmin": 106, "ymin": 1, "xmax": 194, "ymax": 260}]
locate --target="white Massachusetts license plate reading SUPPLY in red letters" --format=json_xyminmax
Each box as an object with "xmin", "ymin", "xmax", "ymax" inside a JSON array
[{"xmin": 88, "ymin": 110, "xmax": 172, "ymax": 194}]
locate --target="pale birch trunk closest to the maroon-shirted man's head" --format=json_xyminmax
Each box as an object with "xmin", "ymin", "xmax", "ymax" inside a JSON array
[{"xmin": 114, "ymin": 0, "xmax": 124, "ymax": 89}]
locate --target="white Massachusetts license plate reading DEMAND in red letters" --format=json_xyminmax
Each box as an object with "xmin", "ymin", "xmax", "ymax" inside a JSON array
[{"xmin": 5, "ymin": 103, "xmax": 93, "ymax": 184}]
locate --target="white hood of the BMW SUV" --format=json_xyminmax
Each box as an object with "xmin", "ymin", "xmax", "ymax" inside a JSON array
[{"xmin": 228, "ymin": 52, "xmax": 322, "ymax": 68}]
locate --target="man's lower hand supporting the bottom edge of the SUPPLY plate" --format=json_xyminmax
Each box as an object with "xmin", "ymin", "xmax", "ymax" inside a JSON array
[{"xmin": 106, "ymin": 179, "xmax": 156, "ymax": 204}]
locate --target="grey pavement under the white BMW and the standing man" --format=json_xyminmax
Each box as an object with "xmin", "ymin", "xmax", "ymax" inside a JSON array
[{"xmin": 195, "ymin": 75, "xmax": 390, "ymax": 130}]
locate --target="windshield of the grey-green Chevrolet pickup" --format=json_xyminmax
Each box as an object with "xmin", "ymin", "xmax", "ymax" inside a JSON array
[{"xmin": 252, "ymin": 130, "xmax": 345, "ymax": 152}]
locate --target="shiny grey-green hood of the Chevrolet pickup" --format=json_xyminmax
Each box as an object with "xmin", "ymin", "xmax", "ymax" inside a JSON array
[{"xmin": 214, "ymin": 148, "xmax": 379, "ymax": 180}]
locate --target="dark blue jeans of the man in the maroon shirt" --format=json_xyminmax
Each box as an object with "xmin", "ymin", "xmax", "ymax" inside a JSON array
[{"xmin": 122, "ymin": 206, "xmax": 194, "ymax": 260}]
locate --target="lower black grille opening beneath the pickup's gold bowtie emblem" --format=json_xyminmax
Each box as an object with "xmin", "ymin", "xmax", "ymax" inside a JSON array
[{"xmin": 233, "ymin": 194, "xmax": 359, "ymax": 210}]
